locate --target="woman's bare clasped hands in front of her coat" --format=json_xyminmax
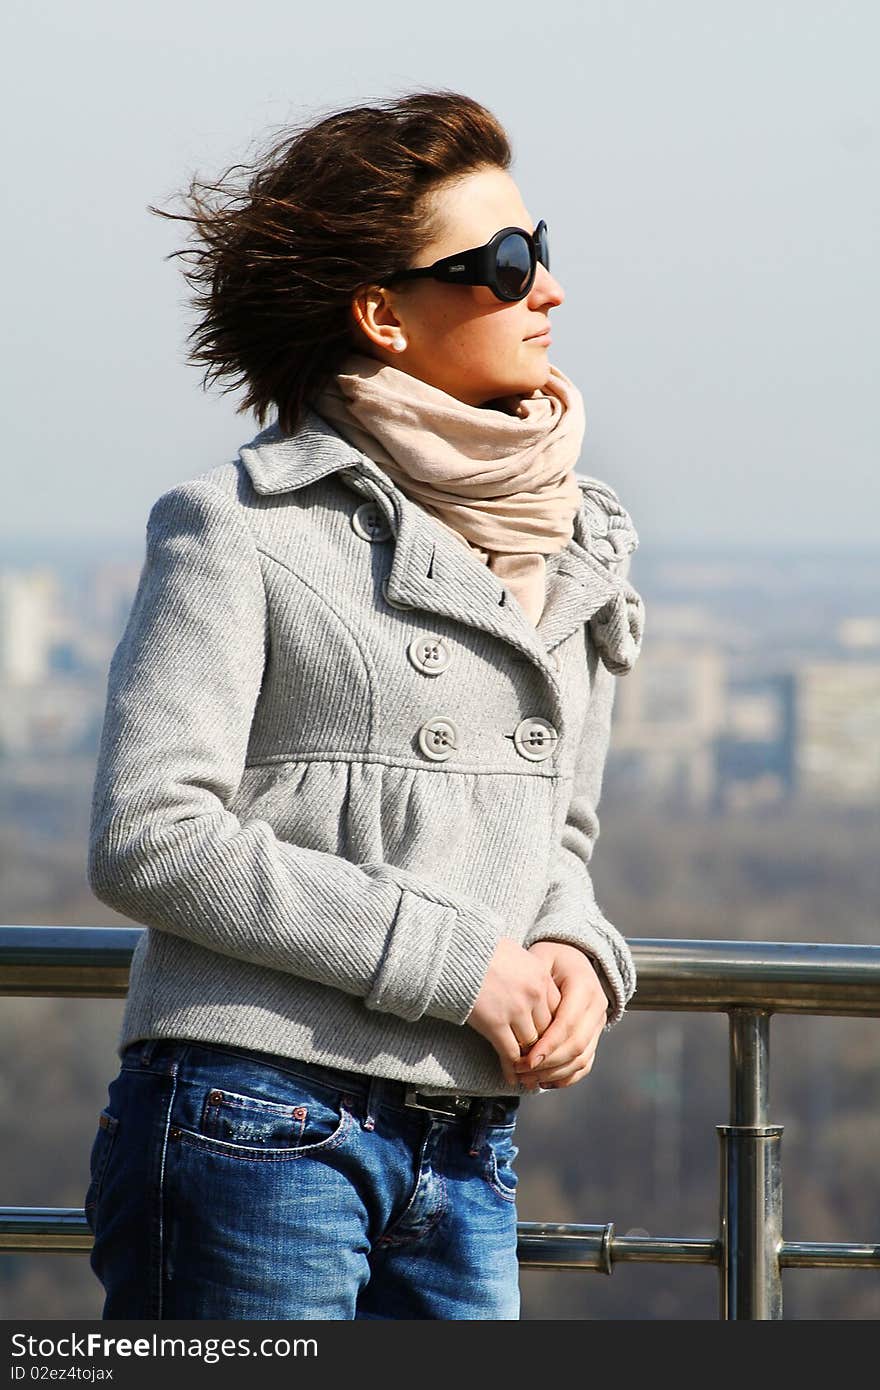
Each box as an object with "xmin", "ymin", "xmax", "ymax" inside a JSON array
[{"xmin": 467, "ymin": 937, "xmax": 608, "ymax": 1091}]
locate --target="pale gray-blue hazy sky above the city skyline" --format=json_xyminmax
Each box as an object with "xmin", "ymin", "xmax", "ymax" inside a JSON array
[{"xmin": 0, "ymin": 0, "xmax": 880, "ymax": 553}]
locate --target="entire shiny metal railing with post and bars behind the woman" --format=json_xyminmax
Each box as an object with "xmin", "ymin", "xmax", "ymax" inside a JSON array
[{"xmin": 0, "ymin": 927, "xmax": 880, "ymax": 1319}]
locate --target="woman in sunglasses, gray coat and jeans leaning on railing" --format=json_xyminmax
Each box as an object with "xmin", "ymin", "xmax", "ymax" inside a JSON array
[{"xmin": 85, "ymin": 92, "xmax": 644, "ymax": 1319}]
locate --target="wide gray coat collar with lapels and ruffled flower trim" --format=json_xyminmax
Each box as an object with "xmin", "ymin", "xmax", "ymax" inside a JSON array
[{"xmin": 239, "ymin": 407, "xmax": 644, "ymax": 685}]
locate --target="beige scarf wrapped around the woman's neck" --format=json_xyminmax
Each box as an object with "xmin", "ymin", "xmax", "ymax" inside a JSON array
[{"xmin": 314, "ymin": 352, "xmax": 585, "ymax": 624}]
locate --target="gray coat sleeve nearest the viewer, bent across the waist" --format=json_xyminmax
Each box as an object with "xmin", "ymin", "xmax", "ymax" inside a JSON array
[{"xmin": 88, "ymin": 480, "xmax": 505, "ymax": 1024}]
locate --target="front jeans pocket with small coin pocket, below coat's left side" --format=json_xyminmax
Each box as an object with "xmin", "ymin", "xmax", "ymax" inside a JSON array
[{"xmin": 174, "ymin": 1077, "xmax": 355, "ymax": 1161}]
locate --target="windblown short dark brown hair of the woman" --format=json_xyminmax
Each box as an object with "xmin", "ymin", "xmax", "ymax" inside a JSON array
[{"xmin": 149, "ymin": 90, "xmax": 512, "ymax": 434}]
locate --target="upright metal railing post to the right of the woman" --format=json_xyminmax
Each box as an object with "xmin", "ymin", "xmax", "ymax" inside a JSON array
[{"xmin": 716, "ymin": 1008, "xmax": 783, "ymax": 1319}]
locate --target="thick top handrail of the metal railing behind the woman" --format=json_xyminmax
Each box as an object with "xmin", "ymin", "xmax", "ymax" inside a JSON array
[{"xmin": 0, "ymin": 926, "xmax": 880, "ymax": 1017}]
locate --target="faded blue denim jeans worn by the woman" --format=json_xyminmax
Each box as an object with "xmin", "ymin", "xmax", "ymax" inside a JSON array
[{"xmin": 83, "ymin": 1041, "xmax": 520, "ymax": 1319}]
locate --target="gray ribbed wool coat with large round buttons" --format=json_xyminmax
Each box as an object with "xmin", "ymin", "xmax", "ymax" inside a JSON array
[{"xmin": 88, "ymin": 411, "xmax": 644, "ymax": 1095}]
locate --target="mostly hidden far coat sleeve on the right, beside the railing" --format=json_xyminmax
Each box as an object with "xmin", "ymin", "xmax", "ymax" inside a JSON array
[{"xmin": 523, "ymin": 644, "xmax": 635, "ymax": 1031}]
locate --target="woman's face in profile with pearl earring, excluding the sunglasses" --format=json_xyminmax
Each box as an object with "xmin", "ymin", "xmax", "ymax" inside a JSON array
[{"xmin": 352, "ymin": 168, "xmax": 564, "ymax": 406}]
